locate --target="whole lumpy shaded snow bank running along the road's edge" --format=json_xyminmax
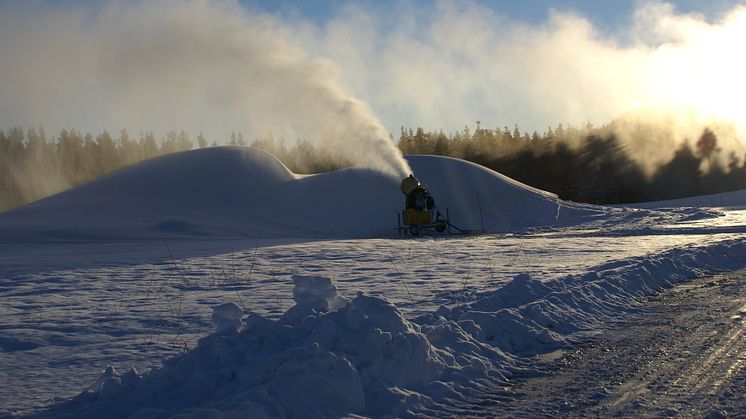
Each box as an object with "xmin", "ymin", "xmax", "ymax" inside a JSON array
[{"xmin": 36, "ymin": 240, "xmax": 746, "ymax": 418}]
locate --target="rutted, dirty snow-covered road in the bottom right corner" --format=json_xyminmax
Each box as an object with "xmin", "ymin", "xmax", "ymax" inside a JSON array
[{"xmin": 491, "ymin": 272, "xmax": 746, "ymax": 417}]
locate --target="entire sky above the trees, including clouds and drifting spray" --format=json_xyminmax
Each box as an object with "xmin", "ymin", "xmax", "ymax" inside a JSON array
[{"xmin": 0, "ymin": 0, "xmax": 746, "ymax": 144}]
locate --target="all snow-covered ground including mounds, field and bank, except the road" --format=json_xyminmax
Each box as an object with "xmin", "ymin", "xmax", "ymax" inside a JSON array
[{"xmin": 0, "ymin": 147, "xmax": 746, "ymax": 417}]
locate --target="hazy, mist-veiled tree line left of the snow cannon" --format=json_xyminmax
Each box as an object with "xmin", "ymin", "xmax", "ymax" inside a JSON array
[{"xmin": 0, "ymin": 127, "xmax": 347, "ymax": 211}]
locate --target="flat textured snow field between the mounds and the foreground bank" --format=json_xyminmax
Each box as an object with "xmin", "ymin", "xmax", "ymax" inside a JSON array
[{"xmin": 0, "ymin": 235, "xmax": 708, "ymax": 412}]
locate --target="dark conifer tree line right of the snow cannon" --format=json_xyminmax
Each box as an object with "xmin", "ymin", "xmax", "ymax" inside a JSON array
[{"xmin": 399, "ymin": 121, "xmax": 746, "ymax": 204}]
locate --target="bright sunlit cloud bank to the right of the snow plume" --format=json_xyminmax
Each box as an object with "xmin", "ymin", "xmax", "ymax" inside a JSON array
[{"xmin": 298, "ymin": 2, "xmax": 746, "ymax": 136}]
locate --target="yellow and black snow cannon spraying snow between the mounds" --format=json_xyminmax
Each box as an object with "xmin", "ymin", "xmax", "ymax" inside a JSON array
[{"xmin": 397, "ymin": 175, "xmax": 450, "ymax": 236}]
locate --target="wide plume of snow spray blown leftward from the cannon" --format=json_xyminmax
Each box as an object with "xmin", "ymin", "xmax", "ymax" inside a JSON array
[{"xmin": 0, "ymin": 0, "xmax": 410, "ymax": 178}]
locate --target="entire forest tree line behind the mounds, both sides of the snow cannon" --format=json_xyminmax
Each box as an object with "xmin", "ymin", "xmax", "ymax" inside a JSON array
[{"xmin": 0, "ymin": 121, "xmax": 746, "ymax": 211}]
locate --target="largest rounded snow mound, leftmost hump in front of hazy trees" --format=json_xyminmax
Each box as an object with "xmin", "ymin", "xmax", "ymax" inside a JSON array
[{"xmin": 0, "ymin": 147, "xmax": 295, "ymax": 240}]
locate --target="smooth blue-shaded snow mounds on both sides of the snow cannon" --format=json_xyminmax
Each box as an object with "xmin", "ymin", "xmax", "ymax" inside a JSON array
[{"xmin": 0, "ymin": 147, "xmax": 602, "ymax": 241}]
